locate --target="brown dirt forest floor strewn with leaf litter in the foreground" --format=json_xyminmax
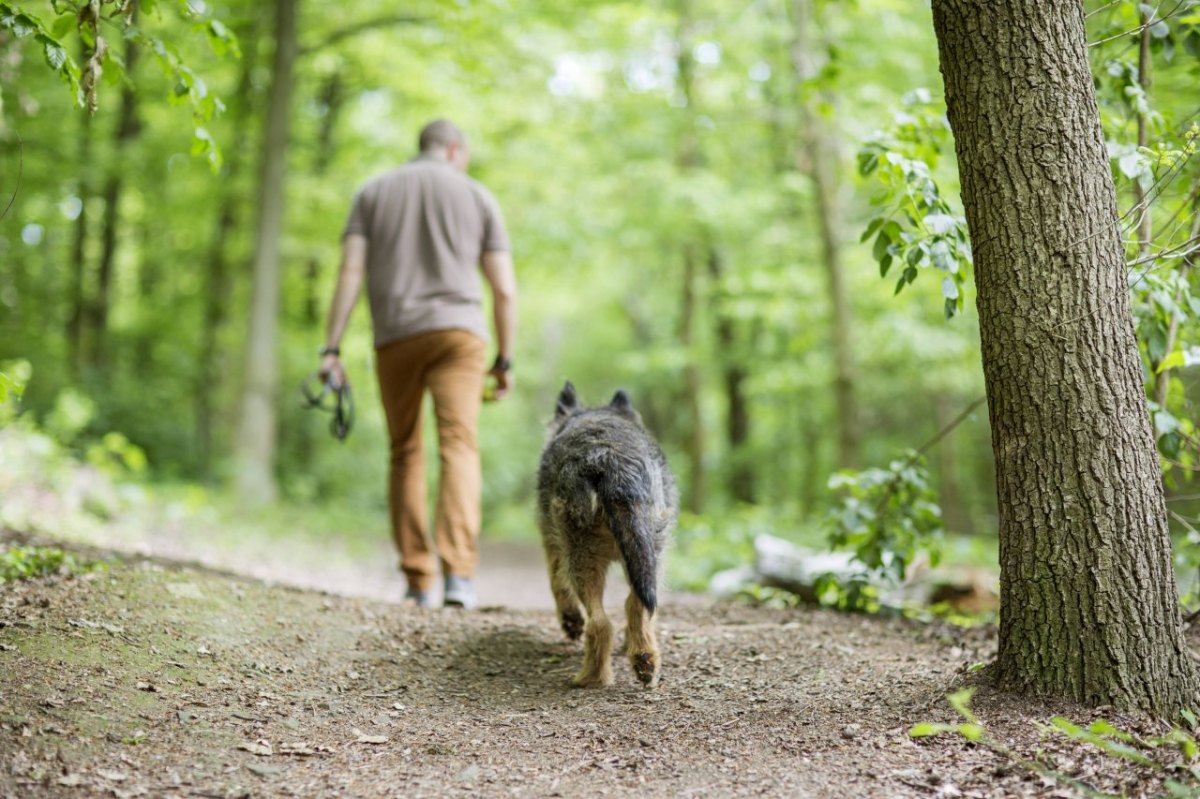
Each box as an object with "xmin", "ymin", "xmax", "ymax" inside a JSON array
[{"xmin": 0, "ymin": 534, "xmax": 1190, "ymax": 798}]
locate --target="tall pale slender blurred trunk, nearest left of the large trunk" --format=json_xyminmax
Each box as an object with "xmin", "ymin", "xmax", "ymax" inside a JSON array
[{"xmin": 792, "ymin": 0, "xmax": 860, "ymax": 468}]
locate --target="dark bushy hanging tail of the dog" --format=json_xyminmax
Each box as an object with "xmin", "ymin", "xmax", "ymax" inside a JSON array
[{"xmin": 592, "ymin": 453, "xmax": 659, "ymax": 614}]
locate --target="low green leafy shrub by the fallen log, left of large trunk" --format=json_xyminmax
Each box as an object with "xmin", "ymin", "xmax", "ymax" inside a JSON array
[{"xmin": 826, "ymin": 451, "xmax": 942, "ymax": 582}]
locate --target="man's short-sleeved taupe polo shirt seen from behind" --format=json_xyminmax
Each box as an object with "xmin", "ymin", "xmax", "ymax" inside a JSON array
[{"xmin": 342, "ymin": 156, "xmax": 509, "ymax": 347}]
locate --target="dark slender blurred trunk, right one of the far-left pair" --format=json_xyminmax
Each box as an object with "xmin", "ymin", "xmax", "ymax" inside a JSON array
[{"xmin": 88, "ymin": 2, "xmax": 140, "ymax": 368}]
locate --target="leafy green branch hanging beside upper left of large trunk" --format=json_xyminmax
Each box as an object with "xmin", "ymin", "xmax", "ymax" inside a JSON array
[{"xmin": 858, "ymin": 89, "xmax": 972, "ymax": 319}]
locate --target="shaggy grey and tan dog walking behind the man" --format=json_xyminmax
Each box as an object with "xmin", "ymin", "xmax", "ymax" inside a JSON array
[{"xmin": 538, "ymin": 382, "xmax": 679, "ymax": 687}]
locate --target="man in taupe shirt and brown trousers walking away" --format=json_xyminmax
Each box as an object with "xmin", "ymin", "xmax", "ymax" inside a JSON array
[{"xmin": 322, "ymin": 120, "xmax": 517, "ymax": 608}]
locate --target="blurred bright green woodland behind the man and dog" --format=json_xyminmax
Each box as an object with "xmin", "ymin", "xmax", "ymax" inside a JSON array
[{"xmin": 0, "ymin": 0, "xmax": 1200, "ymax": 597}]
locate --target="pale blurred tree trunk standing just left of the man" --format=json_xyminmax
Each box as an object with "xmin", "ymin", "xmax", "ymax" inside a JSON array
[{"xmin": 234, "ymin": 0, "xmax": 298, "ymax": 504}]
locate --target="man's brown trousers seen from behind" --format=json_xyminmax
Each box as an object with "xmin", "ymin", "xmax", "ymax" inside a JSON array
[{"xmin": 376, "ymin": 330, "xmax": 485, "ymax": 590}]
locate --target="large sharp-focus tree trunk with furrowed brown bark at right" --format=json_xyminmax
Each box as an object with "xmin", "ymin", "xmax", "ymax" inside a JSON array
[{"xmin": 934, "ymin": 0, "xmax": 1200, "ymax": 714}]
